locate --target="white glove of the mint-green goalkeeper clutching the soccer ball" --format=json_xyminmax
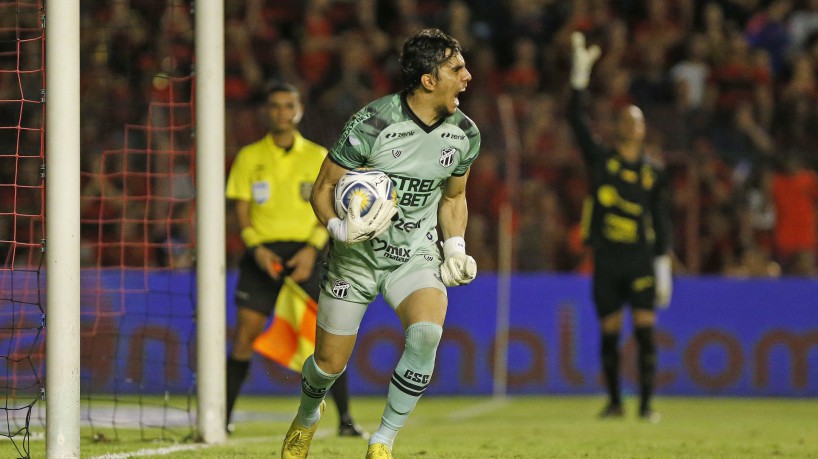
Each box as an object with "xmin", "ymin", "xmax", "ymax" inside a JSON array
[{"xmin": 327, "ymin": 196, "xmax": 398, "ymax": 244}]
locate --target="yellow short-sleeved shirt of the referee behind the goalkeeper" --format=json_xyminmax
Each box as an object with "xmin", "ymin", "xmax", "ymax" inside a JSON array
[{"xmin": 226, "ymin": 132, "xmax": 329, "ymax": 248}]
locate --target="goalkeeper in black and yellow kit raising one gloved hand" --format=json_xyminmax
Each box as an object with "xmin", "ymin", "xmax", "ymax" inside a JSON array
[{"xmin": 569, "ymin": 32, "xmax": 671, "ymax": 422}]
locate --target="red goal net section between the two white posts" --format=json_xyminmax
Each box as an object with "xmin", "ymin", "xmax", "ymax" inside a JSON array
[{"xmin": 80, "ymin": 76, "xmax": 195, "ymax": 441}]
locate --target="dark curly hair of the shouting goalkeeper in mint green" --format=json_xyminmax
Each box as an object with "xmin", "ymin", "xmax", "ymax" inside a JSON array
[{"xmin": 400, "ymin": 29, "xmax": 462, "ymax": 94}]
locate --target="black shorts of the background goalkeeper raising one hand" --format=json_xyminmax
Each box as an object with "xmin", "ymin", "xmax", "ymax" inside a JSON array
[{"xmin": 593, "ymin": 249, "xmax": 656, "ymax": 318}]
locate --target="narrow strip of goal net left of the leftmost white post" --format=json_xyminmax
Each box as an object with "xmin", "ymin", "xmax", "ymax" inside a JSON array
[{"xmin": 0, "ymin": 0, "xmax": 45, "ymax": 457}]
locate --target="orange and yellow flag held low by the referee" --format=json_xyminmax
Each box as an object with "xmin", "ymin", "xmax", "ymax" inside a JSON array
[{"xmin": 253, "ymin": 277, "xmax": 318, "ymax": 372}]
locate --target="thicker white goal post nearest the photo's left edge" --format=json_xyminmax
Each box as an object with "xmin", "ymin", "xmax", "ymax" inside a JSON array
[{"xmin": 45, "ymin": 0, "xmax": 80, "ymax": 459}]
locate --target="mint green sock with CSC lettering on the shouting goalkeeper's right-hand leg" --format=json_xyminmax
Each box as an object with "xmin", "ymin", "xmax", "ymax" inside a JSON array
[{"xmin": 369, "ymin": 322, "xmax": 443, "ymax": 448}]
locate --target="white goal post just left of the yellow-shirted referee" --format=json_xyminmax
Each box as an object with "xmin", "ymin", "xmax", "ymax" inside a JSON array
[{"xmin": 194, "ymin": 1, "xmax": 227, "ymax": 443}]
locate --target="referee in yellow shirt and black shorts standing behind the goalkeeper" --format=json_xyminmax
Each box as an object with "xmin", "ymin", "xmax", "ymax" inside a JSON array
[{"xmin": 226, "ymin": 82, "xmax": 363, "ymax": 436}]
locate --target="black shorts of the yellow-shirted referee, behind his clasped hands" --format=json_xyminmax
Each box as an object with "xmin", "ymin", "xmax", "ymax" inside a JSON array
[{"xmin": 235, "ymin": 242, "xmax": 321, "ymax": 316}]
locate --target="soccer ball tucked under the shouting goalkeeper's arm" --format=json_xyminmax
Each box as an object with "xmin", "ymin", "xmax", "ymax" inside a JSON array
[{"xmin": 335, "ymin": 168, "xmax": 398, "ymax": 218}]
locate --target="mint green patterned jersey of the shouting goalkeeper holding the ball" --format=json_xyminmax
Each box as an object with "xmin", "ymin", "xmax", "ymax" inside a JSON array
[{"xmin": 329, "ymin": 94, "xmax": 480, "ymax": 268}]
